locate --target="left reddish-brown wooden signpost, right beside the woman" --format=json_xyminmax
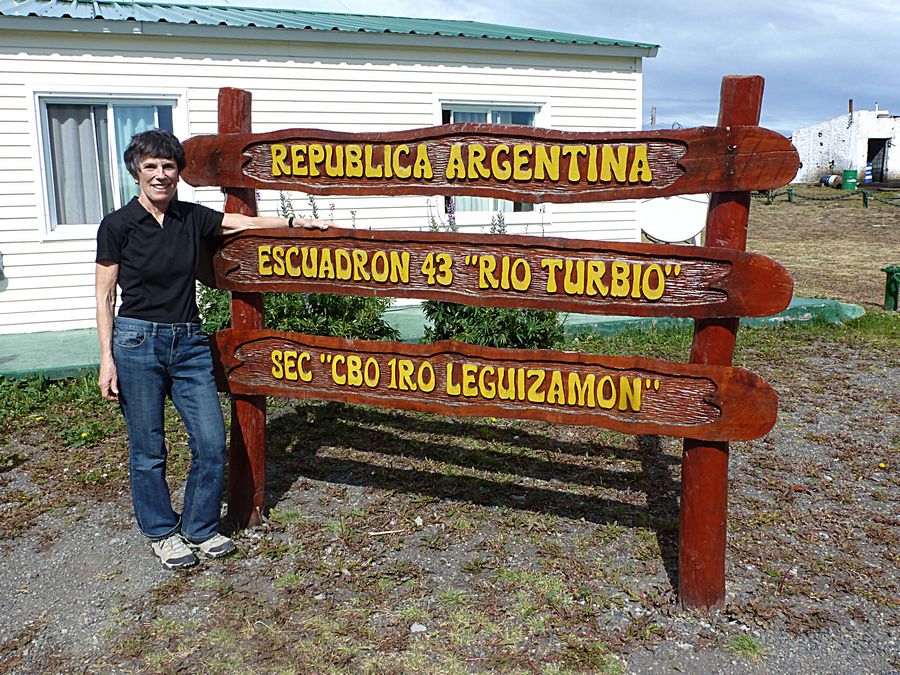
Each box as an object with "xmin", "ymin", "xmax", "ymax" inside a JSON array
[{"xmin": 219, "ymin": 87, "xmax": 266, "ymax": 527}]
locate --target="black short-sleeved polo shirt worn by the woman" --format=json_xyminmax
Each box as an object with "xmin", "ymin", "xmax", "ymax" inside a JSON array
[{"xmin": 97, "ymin": 197, "xmax": 224, "ymax": 323}]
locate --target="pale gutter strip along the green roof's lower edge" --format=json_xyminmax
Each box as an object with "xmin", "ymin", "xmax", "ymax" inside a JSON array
[{"xmin": 0, "ymin": 16, "xmax": 659, "ymax": 58}]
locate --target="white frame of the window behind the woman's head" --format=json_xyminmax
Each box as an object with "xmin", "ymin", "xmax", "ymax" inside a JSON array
[{"xmin": 30, "ymin": 87, "xmax": 188, "ymax": 241}]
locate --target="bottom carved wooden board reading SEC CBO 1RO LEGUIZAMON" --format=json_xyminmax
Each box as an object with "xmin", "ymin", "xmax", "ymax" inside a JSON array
[{"xmin": 215, "ymin": 329, "xmax": 777, "ymax": 440}]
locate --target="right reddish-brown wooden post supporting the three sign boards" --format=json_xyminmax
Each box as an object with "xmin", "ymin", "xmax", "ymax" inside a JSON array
[{"xmin": 678, "ymin": 76, "xmax": 763, "ymax": 608}]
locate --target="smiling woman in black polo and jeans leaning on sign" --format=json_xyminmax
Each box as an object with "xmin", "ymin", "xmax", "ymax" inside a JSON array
[{"xmin": 96, "ymin": 129, "xmax": 327, "ymax": 569}]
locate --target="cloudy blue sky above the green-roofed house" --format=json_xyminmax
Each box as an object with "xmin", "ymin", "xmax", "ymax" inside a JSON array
[{"xmin": 203, "ymin": 0, "xmax": 900, "ymax": 134}]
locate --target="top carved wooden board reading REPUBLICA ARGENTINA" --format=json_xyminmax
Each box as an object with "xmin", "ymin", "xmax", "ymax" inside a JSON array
[{"xmin": 182, "ymin": 124, "xmax": 800, "ymax": 203}]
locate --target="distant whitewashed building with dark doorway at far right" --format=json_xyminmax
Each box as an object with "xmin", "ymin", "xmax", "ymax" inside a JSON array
[{"xmin": 791, "ymin": 110, "xmax": 900, "ymax": 183}]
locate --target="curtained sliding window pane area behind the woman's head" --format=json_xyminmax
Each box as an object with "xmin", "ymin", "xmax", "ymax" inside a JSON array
[{"xmin": 41, "ymin": 97, "xmax": 174, "ymax": 230}]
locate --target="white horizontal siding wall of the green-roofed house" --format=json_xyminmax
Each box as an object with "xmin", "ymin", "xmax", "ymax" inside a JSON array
[{"xmin": 0, "ymin": 31, "xmax": 641, "ymax": 333}]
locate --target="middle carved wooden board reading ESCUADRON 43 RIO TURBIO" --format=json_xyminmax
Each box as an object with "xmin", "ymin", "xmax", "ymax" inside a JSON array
[{"xmin": 213, "ymin": 228, "xmax": 793, "ymax": 317}]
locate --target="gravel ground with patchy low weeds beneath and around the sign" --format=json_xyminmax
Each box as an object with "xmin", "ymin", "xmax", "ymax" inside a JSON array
[{"xmin": 0, "ymin": 328, "xmax": 900, "ymax": 673}]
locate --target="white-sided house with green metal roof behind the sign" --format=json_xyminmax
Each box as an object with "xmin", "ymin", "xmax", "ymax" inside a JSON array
[{"xmin": 0, "ymin": 0, "xmax": 657, "ymax": 333}]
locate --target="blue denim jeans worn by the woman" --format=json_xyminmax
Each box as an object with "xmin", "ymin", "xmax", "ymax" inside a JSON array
[{"xmin": 113, "ymin": 317, "xmax": 225, "ymax": 543}]
